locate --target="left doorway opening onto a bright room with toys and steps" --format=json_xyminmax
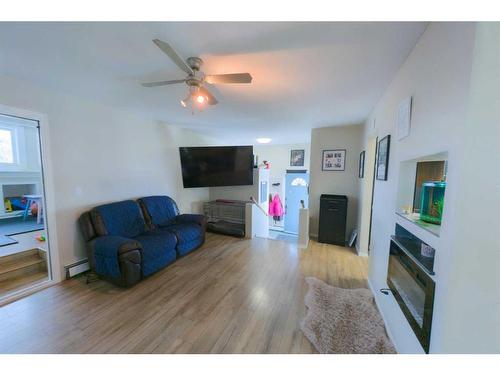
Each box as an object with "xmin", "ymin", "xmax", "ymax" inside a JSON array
[{"xmin": 0, "ymin": 113, "xmax": 51, "ymax": 301}]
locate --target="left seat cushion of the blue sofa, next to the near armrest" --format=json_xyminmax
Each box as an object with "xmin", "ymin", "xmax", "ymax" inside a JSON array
[{"xmin": 134, "ymin": 231, "xmax": 177, "ymax": 276}]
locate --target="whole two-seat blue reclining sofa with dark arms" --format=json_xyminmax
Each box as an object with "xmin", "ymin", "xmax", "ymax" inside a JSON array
[{"xmin": 79, "ymin": 196, "xmax": 206, "ymax": 287}]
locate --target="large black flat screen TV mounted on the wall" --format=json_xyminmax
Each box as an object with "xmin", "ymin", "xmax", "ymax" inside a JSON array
[{"xmin": 179, "ymin": 146, "xmax": 253, "ymax": 188}]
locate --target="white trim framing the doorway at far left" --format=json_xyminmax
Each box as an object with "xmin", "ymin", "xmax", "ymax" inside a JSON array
[{"xmin": 0, "ymin": 104, "xmax": 63, "ymax": 283}]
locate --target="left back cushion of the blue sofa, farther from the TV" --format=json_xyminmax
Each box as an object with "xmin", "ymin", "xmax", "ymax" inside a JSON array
[{"xmin": 91, "ymin": 200, "xmax": 146, "ymax": 238}]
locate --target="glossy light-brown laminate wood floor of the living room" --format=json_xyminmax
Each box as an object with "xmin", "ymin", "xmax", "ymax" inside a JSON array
[{"xmin": 0, "ymin": 234, "xmax": 368, "ymax": 353}]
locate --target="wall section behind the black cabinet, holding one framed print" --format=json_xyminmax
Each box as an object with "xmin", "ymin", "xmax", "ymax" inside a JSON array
[{"xmin": 309, "ymin": 125, "xmax": 363, "ymax": 238}]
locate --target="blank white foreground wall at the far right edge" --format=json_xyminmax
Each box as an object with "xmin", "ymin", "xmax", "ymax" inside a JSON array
[{"xmin": 433, "ymin": 23, "xmax": 500, "ymax": 353}]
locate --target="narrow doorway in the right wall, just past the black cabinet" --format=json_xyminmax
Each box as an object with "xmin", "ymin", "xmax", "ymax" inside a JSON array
[{"xmin": 357, "ymin": 137, "xmax": 377, "ymax": 255}]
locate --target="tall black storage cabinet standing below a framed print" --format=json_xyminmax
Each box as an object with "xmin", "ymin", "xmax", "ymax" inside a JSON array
[{"xmin": 318, "ymin": 194, "xmax": 347, "ymax": 246}]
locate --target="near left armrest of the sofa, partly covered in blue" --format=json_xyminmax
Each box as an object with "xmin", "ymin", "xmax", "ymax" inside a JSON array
[{"xmin": 88, "ymin": 236, "xmax": 142, "ymax": 286}]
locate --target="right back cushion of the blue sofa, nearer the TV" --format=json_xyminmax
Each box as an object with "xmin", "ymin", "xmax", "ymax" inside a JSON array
[{"xmin": 139, "ymin": 195, "xmax": 179, "ymax": 227}]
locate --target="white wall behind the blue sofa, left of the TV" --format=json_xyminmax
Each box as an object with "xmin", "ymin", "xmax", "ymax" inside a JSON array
[{"xmin": 0, "ymin": 76, "xmax": 216, "ymax": 276}]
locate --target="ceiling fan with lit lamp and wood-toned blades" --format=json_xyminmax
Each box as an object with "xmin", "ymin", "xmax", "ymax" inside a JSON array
[{"xmin": 142, "ymin": 39, "xmax": 252, "ymax": 113}]
